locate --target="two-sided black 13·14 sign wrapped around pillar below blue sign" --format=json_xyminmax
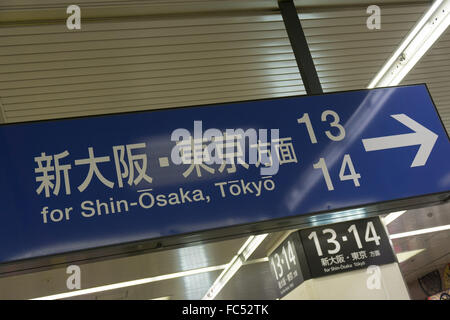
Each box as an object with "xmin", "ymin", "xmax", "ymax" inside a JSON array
[{"xmin": 269, "ymin": 217, "xmax": 396, "ymax": 297}]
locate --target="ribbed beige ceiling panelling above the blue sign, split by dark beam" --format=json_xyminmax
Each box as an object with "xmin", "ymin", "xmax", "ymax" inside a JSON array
[{"xmin": 0, "ymin": 5, "xmax": 426, "ymax": 122}]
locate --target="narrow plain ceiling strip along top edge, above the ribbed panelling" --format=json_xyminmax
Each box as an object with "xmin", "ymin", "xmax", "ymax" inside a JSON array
[{"xmin": 0, "ymin": 0, "xmax": 425, "ymax": 23}]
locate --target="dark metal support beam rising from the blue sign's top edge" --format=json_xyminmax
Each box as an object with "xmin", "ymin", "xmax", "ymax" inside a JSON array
[{"xmin": 278, "ymin": 0, "xmax": 323, "ymax": 94}]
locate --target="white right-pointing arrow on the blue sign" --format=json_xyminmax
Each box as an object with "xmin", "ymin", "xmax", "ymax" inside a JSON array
[{"xmin": 362, "ymin": 113, "xmax": 438, "ymax": 167}]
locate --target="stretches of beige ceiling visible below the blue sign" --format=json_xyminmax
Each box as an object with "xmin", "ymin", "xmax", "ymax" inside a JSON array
[{"xmin": 0, "ymin": 203, "xmax": 450, "ymax": 300}]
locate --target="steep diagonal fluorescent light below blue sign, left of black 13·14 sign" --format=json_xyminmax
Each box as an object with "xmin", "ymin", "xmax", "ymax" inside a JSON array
[{"xmin": 202, "ymin": 233, "xmax": 268, "ymax": 300}]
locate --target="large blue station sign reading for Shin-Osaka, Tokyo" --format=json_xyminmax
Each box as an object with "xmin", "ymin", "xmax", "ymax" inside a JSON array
[{"xmin": 0, "ymin": 85, "xmax": 450, "ymax": 263}]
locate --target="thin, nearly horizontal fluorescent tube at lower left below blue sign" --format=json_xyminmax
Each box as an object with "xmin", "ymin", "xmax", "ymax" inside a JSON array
[{"xmin": 31, "ymin": 264, "xmax": 227, "ymax": 300}]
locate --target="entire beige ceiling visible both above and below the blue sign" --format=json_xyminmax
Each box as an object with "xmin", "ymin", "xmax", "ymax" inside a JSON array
[{"xmin": 0, "ymin": 0, "xmax": 450, "ymax": 299}]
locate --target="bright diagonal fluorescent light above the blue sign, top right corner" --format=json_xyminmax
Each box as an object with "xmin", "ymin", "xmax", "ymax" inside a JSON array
[{"xmin": 368, "ymin": 0, "xmax": 450, "ymax": 89}]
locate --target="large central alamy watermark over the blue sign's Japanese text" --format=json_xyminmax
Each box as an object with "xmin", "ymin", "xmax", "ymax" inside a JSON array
[{"xmin": 171, "ymin": 121, "xmax": 297, "ymax": 177}]
